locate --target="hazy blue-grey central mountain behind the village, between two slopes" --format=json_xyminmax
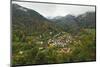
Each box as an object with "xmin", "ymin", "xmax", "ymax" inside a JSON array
[{"xmin": 52, "ymin": 14, "xmax": 79, "ymax": 32}]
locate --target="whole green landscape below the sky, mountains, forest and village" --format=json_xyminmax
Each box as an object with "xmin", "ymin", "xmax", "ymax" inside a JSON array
[{"xmin": 12, "ymin": 4, "xmax": 96, "ymax": 65}]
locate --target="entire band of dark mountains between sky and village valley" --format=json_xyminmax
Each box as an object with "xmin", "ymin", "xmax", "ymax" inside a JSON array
[{"xmin": 12, "ymin": 4, "xmax": 95, "ymax": 32}]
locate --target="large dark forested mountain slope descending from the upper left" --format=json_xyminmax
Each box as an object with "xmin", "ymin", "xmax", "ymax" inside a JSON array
[{"xmin": 12, "ymin": 4, "xmax": 58, "ymax": 33}]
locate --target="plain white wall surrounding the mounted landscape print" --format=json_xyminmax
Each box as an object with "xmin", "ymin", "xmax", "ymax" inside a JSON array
[{"xmin": 0, "ymin": 0, "xmax": 100, "ymax": 67}]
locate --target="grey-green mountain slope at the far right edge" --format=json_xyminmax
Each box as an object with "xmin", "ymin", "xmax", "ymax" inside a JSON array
[{"xmin": 77, "ymin": 12, "xmax": 96, "ymax": 28}]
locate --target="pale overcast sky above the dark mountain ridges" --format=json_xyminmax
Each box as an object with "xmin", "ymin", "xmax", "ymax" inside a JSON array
[{"xmin": 13, "ymin": 1, "xmax": 95, "ymax": 17}]
